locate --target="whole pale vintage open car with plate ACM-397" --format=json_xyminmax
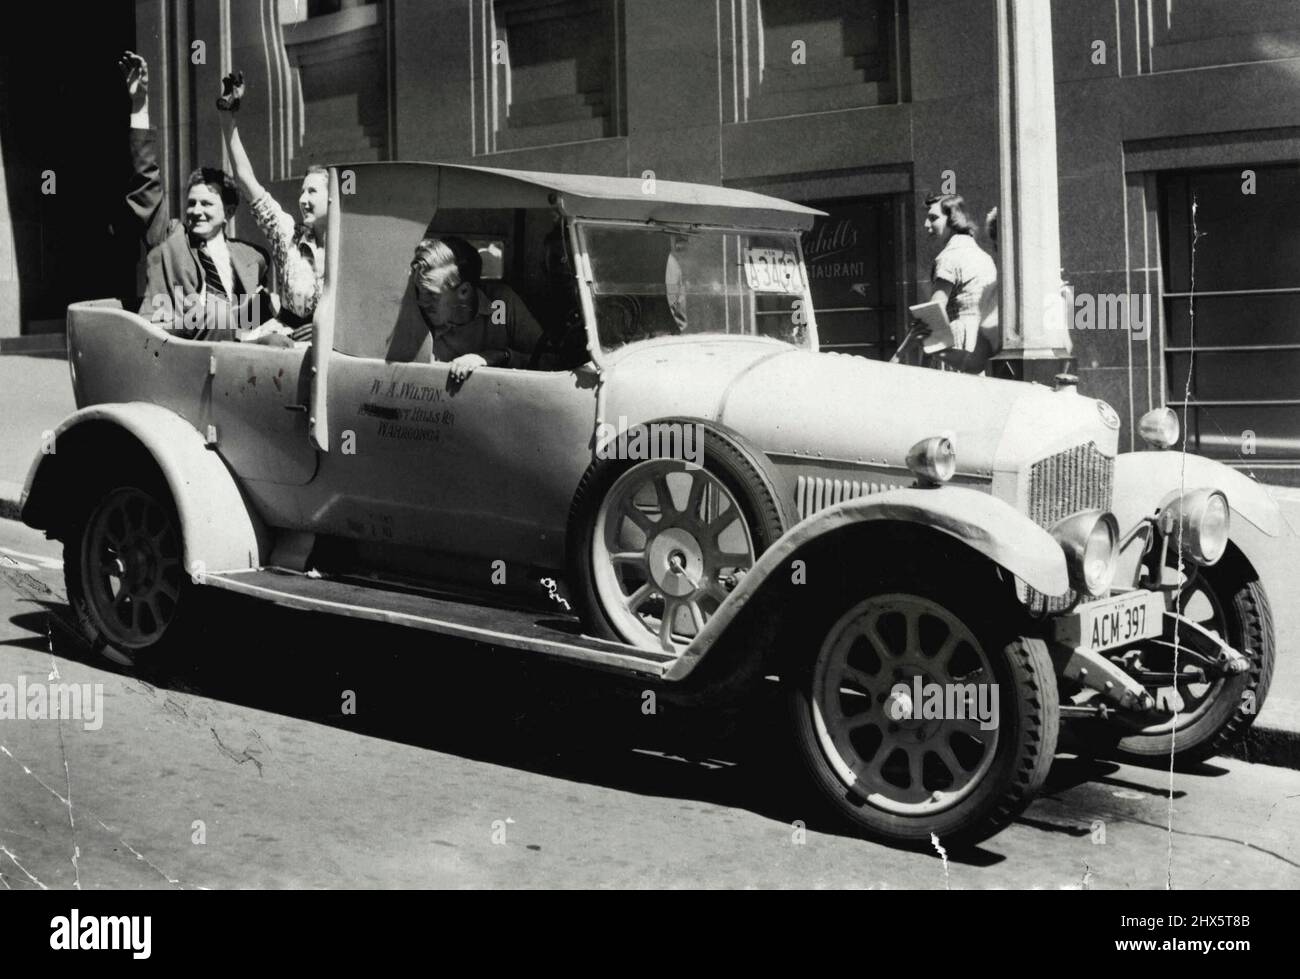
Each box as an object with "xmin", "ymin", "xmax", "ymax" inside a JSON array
[{"xmin": 22, "ymin": 164, "xmax": 1282, "ymax": 845}]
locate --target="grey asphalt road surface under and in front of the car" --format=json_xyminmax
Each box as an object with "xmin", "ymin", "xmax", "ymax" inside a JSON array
[{"xmin": 0, "ymin": 521, "xmax": 1300, "ymax": 891}]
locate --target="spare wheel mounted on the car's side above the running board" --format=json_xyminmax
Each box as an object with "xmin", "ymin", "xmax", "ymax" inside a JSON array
[{"xmin": 572, "ymin": 423, "xmax": 788, "ymax": 653}]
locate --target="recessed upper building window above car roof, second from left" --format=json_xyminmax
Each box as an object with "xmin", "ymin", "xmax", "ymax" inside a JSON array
[{"xmin": 476, "ymin": 0, "xmax": 624, "ymax": 152}]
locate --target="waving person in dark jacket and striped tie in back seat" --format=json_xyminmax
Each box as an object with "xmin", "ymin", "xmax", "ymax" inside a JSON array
[{"xmin": 120, "ymin": 52, "xmax": 274, "ymax": 341}]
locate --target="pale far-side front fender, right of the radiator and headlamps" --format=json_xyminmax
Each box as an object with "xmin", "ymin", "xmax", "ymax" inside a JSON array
[{"xmin": 1112, "ymin": 452, "xmax": 1286, "ymax": 537}]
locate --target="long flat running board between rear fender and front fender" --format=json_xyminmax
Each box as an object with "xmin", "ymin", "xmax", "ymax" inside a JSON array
[{"xmin": 203, "ymin": 568, "xmax": 677, "ymax": 677}]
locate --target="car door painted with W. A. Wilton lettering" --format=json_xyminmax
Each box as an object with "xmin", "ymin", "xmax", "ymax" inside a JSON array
[{"xmin": 317, "ymin": 351, "xmax": 595, "ymax": 568}]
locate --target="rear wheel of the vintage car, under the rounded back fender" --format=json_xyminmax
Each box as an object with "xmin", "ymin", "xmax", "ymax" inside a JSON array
[{"xmin": 64, "ymin": 478, "xmax": 194, "ymax": 664}]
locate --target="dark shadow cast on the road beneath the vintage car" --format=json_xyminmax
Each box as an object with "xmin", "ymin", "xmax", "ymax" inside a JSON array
[{"xmin": 10, "ymin": 593, "xmax": 1005, "ymax": 866}]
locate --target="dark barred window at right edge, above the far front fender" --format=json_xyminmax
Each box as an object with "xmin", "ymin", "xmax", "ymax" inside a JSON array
[{"xmin": 1158, "ymin": 165, "xmax": 1300, "ymax": 467}]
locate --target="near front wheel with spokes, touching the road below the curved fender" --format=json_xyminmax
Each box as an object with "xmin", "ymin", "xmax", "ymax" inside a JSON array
[{"xmin": 784, "ymin": 585, "xmax": 1060, "ymax": 846}]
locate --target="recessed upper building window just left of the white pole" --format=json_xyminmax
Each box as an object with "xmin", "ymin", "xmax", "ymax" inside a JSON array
[{"xmin": 723, "ymin": 0, "xmax": 906, "ymax": 122}]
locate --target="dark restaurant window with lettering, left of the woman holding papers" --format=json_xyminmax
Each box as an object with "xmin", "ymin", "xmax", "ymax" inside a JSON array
[{"xmin": 803, "ymin": 196, "xmax": 906, "ymax": 360}]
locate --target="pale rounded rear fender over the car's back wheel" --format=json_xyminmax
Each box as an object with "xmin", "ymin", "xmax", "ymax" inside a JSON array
[{"xmin": 20, "ymin": 402, "xmax": 269, "ymax": 572}]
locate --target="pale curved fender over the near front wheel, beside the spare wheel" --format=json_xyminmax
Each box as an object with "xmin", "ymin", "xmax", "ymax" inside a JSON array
[{"xmin": 666, "ymin": 486, "xmax": 1070, "ymax": 680}]
